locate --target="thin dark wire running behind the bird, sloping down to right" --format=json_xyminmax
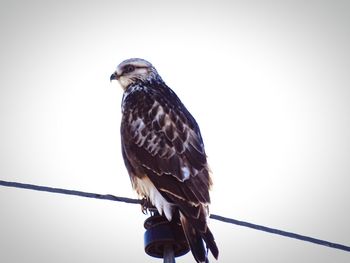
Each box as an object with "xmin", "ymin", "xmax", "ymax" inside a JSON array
[{"xmin": 0, "ymin": 180, "xmax": 350, "ymax": 252}]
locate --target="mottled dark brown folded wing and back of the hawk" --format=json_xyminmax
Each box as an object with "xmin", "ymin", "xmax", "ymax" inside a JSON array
[{"xmin": 121, "ymin": 83, "xmax": 211, "ymax": 207}]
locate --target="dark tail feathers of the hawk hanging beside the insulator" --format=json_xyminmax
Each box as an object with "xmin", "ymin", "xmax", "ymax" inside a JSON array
[{"xmin": 180, "ymin": 212, "xmax": 219, "ymax": 263}]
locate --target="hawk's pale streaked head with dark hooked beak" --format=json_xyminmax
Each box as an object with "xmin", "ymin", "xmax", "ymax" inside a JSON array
[{"xmin": 110, "ymin": 58, "xmax": 160, "ymax": 90}]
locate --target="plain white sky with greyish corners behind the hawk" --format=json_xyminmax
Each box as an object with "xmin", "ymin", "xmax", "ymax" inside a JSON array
[{"xmin": 0, "ymin": 0, "xmax": 350, "ymax": 263}]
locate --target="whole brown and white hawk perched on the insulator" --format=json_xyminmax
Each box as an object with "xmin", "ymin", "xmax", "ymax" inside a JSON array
[{"xmin": 110, "ymin": 58, "xmax": 219, "ymax": 262}]
